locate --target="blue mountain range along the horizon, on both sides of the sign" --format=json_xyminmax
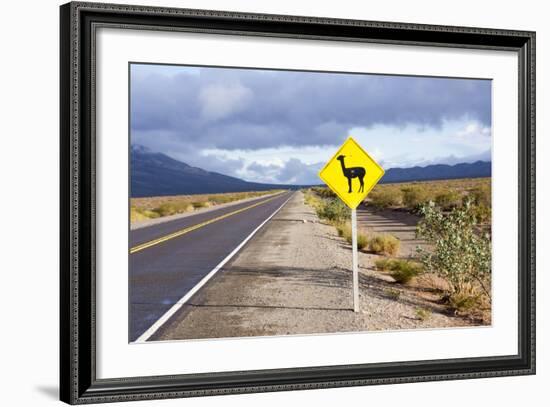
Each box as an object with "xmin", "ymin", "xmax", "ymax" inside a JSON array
[{"xmin": 130, "ymin": 145, "xmax": 491, "ymax": 197}]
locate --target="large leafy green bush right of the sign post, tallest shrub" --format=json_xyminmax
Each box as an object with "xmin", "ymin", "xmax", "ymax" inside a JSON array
[{"xmin": 417, "ymin": 201, "xmax": 491, "ymax": 308}]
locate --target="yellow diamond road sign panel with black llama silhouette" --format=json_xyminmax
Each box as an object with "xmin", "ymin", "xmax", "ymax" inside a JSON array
[{"xmin": 319, "ymin": 137, "xmax": 384, "ymax": 209}]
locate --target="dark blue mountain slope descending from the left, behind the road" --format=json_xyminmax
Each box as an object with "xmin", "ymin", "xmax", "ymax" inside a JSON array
[{"xmin": 130, "ymin": 145, "xmax": 289, "ymax": 197}]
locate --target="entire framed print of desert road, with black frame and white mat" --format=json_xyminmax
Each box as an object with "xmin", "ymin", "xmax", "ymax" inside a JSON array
[{"xmin": 60, "ymin": 2, "xmax": 535, "ymax": 404}]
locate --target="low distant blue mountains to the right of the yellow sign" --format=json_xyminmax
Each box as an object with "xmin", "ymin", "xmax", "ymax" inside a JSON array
[{"xmin": 380, "ymin": 161, "xmax": 491, "ymax": 183}]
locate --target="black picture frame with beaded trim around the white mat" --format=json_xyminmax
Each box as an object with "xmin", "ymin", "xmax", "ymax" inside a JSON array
[{"xmin": 60, "ymin": 2, "xmax": 535, "ymax": 404}]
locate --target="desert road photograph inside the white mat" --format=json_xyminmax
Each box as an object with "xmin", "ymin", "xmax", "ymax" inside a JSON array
[{"xmin": 127, "ymin": 61, "xmax": 494, "ymax": 343}]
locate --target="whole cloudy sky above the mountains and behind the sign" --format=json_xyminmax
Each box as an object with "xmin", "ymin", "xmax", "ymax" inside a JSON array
[{"xmin": 130, "ymin": 64, "xmax": 491, "ymax": 184}]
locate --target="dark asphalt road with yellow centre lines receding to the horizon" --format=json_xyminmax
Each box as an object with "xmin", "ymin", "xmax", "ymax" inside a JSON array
[{"xmin": 128, "ymin": 192, "xmax": 292, "ymax": 342}]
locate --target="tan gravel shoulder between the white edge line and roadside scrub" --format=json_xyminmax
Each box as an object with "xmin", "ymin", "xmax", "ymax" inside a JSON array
[{"xmin": 152, "ymin": 192, "xmax": 474, "ymax": 340}]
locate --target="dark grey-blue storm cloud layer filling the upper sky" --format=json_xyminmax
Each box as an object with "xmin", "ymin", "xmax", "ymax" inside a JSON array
[{"xmin": 131, "ymin": 66, "xmax": 491, "ymax": 154}]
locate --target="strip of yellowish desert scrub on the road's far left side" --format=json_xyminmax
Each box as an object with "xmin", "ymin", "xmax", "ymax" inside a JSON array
[{"xmin": 130, "ymin": 190, "xmax": 280, "ymax": 222}]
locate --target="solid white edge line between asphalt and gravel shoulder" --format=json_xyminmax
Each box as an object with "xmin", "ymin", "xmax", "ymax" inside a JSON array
[{"xmin": 132, "ymin": 193, "xmax": 294, "ymax": 343}]
